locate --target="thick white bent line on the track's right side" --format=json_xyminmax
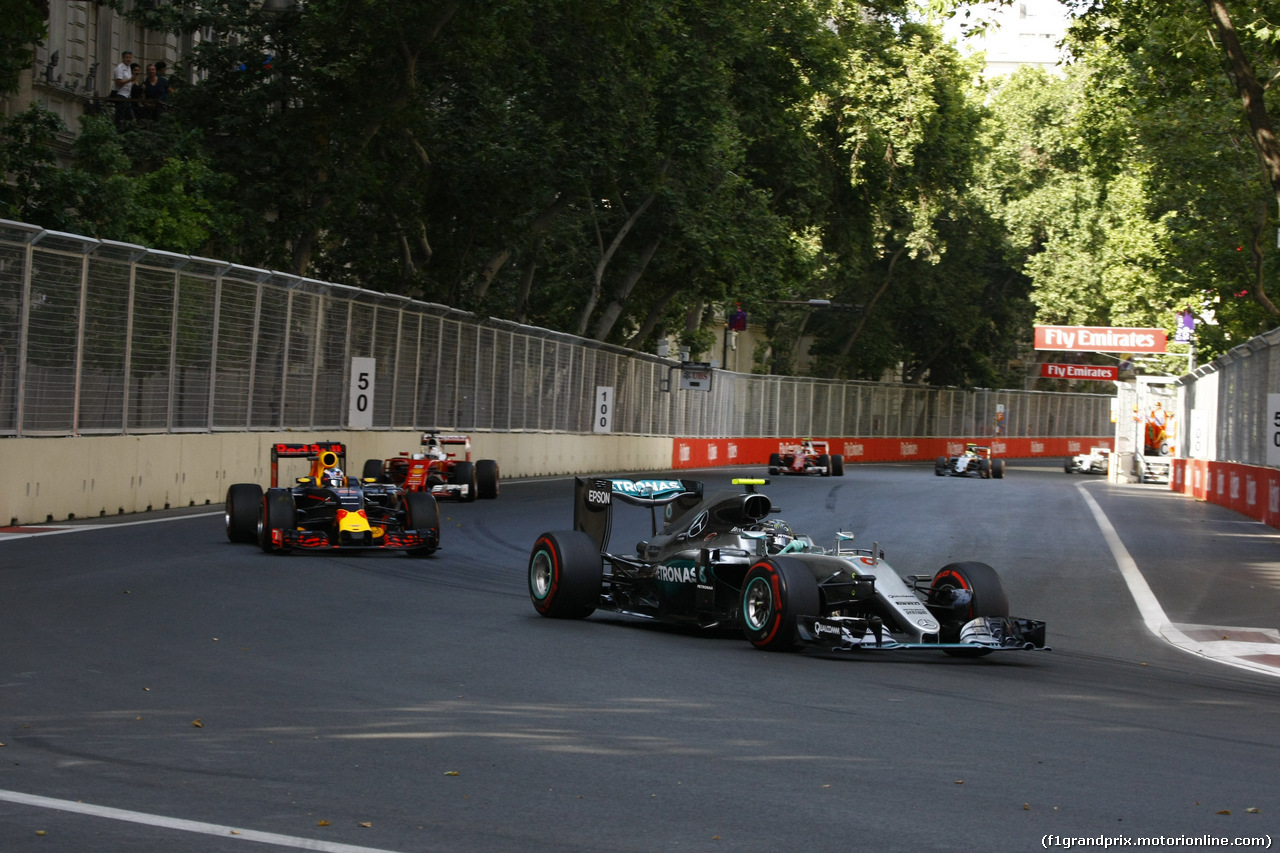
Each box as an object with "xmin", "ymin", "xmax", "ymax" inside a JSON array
[{"xmin": 1075, "ymin": 483, "xmax": 1280, "ymax": 678}]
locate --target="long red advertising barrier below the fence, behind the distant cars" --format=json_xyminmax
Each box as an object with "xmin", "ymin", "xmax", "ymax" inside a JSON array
[{"xmin": 671, "ymin": 435, "xmax": 1114, "ymax": 469}]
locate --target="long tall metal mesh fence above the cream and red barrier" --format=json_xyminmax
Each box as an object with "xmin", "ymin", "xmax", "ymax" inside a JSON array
[{"xmin": 0, "ymin": 220, "xmax": 1112, "ymax": 438}]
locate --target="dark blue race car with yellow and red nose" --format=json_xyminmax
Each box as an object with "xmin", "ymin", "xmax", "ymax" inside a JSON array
[{"xmin": 224, "ymin": 442, "xmax": 440, "ymax": 557}]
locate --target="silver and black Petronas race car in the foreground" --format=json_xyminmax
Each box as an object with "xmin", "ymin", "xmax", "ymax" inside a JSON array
[{"xmin": 529, "ymin": 478, "xmax": 1044, "ymax": 657}]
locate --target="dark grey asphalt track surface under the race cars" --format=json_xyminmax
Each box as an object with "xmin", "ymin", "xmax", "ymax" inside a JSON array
[{"xmin": 0, "ymin": 461, "xmax": 1280, "ymax": 853}]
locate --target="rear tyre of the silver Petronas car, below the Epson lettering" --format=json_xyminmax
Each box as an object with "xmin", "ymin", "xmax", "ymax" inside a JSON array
[{"xmin": 529, "ymin": 530, "xmax": 604, "ymax": 619}]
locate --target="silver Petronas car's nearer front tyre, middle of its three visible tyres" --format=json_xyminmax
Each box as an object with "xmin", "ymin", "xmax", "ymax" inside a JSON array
[{"xmin": 741, "ymin": 557, "xmax": 819, "ymax": 652}]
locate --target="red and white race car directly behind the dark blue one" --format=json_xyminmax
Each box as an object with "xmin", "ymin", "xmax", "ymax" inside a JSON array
[{"xmin": 361, "ymin": 433, "xmax": 498, "ymax": 501}]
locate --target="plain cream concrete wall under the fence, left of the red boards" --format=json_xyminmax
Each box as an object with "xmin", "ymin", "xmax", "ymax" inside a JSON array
[{"xmin": 0, "ymin": 432, "xmax": 672, "ymax": 525}]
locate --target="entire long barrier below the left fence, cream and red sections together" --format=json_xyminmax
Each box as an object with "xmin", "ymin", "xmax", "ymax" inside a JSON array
[{"xmin": 0, "ymin": 430, "xmax": 1110, "ymax": 525}]
